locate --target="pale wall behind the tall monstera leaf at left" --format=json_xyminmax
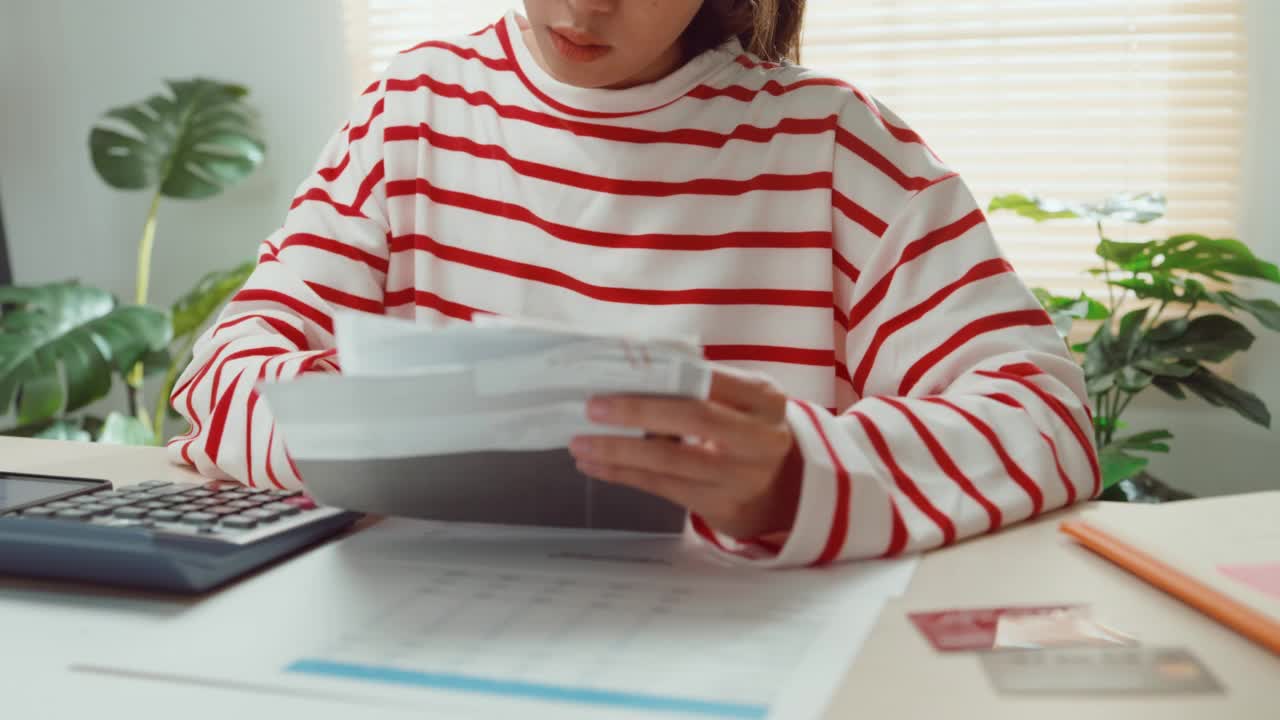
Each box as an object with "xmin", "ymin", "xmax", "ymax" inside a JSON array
[{"xmin": 0, "ymin": 0, "xmax": 351, "ymax": 302}]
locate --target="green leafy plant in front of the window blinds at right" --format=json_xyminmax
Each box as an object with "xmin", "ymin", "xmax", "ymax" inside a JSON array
[{"xmin": 989, "ymin": 193, "xmax": 1280, "ymax": 501}]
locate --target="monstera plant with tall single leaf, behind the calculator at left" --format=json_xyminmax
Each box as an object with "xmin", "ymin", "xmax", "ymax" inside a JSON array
[{"xmin": 0, "ymin": 78, "xmax": 265, "ymax": 445}]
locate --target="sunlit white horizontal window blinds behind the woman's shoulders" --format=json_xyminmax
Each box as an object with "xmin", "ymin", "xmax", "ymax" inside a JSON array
[{"xmin": 347, "ymin": 0, "xmax": 1245, "ymax": 292}]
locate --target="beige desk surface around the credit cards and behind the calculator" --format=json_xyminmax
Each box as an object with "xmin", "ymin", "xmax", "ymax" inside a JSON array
[{"xmin": 0, "ymin": 437, "xmax": 1280, "ymax": 720}]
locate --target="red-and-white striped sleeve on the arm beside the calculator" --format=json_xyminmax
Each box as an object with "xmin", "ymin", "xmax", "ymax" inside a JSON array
[{"xmin": 169, "ymin": 85, "xmax": 388, "ymax": 487}]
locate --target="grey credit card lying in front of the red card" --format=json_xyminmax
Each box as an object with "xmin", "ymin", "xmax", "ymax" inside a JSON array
[{"xmin": 980, "ymin": 647, "xmax": 1222, "ymax": 694}]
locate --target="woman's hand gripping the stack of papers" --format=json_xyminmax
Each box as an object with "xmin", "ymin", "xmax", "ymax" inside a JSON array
[{"xmin": 570, "ymin": 372, "xmax": 800, "ymax": 538}]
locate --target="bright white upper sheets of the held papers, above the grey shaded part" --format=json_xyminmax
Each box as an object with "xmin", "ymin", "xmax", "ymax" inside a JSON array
[{"xmin": 261, "ymin": 313, "xmax": 712, "ymax": 460}]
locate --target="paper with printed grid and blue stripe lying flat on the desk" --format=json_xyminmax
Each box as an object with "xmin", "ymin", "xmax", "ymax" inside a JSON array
[{"xmin": 81, "ymin": 520, "xmax": 916, "ymax": 720}]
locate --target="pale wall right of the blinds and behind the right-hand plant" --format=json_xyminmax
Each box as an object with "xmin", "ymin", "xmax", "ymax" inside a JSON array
[{"xmin": 1128, "ymin": 0, "xmax": 1280, "ymax": 495}]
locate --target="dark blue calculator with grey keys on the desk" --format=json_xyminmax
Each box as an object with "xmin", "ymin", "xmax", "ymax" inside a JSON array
[{"xmin": 0, "ymin": 471, "xmax": 360, "ymax": 593}]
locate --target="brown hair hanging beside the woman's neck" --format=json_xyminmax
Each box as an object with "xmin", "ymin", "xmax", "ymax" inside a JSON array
[{"xmin": 682, "ymin": 0, "xmax": 805, "ymax": 63}]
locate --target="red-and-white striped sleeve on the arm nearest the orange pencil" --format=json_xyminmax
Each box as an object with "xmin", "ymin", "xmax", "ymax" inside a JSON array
[{"xmin": 694, "ymin": 105, "xmax": 1101, "ymax": 566}]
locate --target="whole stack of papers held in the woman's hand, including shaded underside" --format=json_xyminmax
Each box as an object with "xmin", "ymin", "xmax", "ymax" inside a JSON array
[{"xmin": 261, "ymin": 314, "xmax": 712, "ymax": 532}]
